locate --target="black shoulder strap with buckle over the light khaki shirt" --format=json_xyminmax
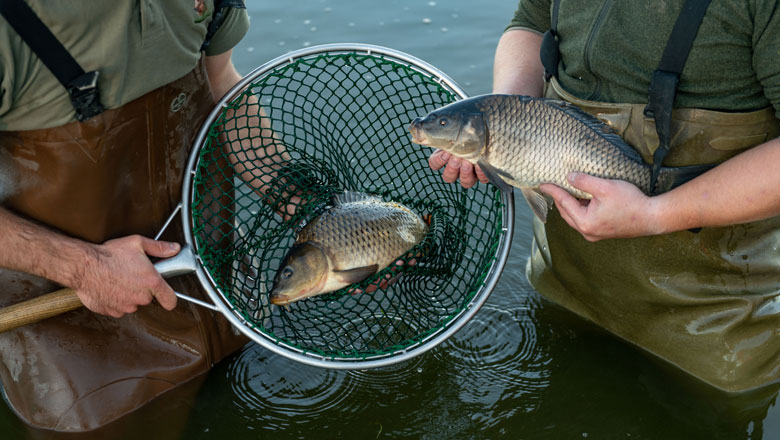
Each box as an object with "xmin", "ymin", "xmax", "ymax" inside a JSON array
[{"xmin": 0, "ymin": 0, "xmax": 103, "ymax": 122}]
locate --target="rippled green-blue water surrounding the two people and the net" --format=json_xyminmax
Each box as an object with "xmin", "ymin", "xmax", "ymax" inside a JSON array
[{"xmin": 0, "ymin": 0, "xmax": 780, "ymax": 439}]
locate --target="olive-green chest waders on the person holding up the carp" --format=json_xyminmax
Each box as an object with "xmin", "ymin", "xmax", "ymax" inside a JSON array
[{"xmin": 527, "ymin": 0, "xmax": 780, "ymax": 391}]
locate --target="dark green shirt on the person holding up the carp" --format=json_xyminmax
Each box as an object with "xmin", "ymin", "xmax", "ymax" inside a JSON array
[{"xmin": 507, "ymin": 0, "xmax": 780, "ymax": 117}]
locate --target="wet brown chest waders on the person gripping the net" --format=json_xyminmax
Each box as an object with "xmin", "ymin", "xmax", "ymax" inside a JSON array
[{"xmin": 0, "ymin": 57, "xmax": 247, "ymax": 431}]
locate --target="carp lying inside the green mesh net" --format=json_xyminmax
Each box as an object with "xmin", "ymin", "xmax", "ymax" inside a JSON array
[{"xmin": 271, "ymin": 192, "xmax": 428, "ymax": 305}]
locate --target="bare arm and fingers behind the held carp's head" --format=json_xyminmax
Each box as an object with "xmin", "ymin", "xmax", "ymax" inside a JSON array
[{"xmin": 428, "ymin": 29, "xmax": 544, "ymax": 188}]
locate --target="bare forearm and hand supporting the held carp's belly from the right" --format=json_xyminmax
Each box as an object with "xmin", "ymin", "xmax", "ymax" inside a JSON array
[{"xmin": 542, "ymin": 139, "xmax": 780, "ymax": 241}]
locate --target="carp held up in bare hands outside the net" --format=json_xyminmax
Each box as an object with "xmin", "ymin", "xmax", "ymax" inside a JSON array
[{"xmin": 409, "ymin": 95, "xmax": 710, "ymax": 221}]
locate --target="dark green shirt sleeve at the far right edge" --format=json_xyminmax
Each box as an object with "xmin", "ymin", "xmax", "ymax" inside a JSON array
[{"xmin": 752, "ymin": 0, "xmax": 780, "ymax": 119}]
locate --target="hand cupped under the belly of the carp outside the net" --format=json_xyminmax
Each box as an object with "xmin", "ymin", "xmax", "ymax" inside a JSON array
[{"xmin": 539, "ymin": 173, "xmax": 664, "ymax": 242}]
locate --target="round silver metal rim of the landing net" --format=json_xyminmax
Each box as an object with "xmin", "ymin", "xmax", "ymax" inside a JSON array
[{"xmin": 181, "ymin": 43, "xmax": 515, "ymax": 369}]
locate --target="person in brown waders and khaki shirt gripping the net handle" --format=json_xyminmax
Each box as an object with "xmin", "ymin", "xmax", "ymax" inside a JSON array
[{"xmin": 0, "ymin": 0, "xmax": 249, "ymax": 432}]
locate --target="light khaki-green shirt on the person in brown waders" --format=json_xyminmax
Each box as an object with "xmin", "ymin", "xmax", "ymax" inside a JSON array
[{"xmin": 0, "ymin": 0, "xmax": 249, "ymax": 131}]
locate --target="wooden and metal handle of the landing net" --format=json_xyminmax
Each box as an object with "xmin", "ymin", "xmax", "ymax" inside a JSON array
[{"xmin": 0, "ymin": 245, "xmax": 220, "ymax": 333}]
